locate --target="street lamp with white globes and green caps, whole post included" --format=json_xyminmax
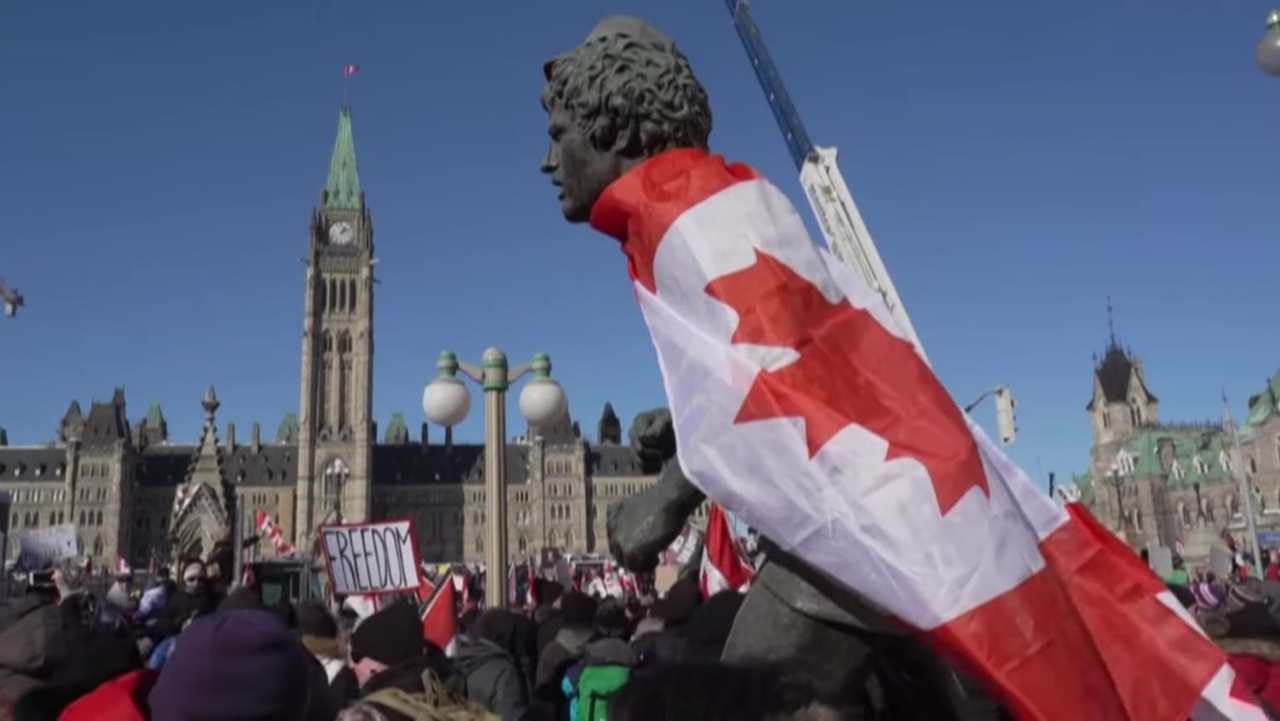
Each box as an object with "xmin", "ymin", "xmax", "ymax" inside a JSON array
[{"xmin": 422, "ymin": 348, "xmax": 564, "ymax": 608}]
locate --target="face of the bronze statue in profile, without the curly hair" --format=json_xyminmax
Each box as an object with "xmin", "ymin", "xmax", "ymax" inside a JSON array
[{"xmin": 541, "ymin": 105, "xmax": 628, "ymax": 223}]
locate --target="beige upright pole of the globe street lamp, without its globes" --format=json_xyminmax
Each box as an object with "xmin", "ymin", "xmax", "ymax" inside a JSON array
[{"xmin": 481, "ymin": 348, "xmax": 507, "ymax": 608}]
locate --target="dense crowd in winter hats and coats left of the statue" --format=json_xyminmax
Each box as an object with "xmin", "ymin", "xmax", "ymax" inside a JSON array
[{"xmin": 0, "ymin": 562, "xmax": 842, "ymax": 721}]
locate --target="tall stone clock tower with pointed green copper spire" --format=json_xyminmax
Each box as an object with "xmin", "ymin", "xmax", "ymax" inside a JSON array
[{"xmin": 294, "ymin": 108, "xmax": 374, "ymax": 549}]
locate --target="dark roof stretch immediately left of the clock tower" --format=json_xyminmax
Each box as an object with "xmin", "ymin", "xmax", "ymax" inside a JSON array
[{"xmin": 138, "ymin": 444, "xmax": 298, "ymax": 485}]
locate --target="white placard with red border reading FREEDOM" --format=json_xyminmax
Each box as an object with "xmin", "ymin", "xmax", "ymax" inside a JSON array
[{"xmin": 320, "ymin": 520, "xmax": 419, "ymax": 595}]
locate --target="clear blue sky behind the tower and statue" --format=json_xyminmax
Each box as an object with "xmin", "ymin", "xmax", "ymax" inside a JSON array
[{"xmin": 0, "ymin": 0, "xmax": 1280, "ymax": 491}]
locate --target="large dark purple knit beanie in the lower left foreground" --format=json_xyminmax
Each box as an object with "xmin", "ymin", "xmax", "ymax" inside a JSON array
[{"xmin": 148, "ymin": 610, "xmax": 307, "ymax": 721}]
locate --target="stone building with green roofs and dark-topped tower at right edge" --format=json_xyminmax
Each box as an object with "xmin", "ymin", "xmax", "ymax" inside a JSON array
[{"xmin": 1075, "ymin": 334, "xmax": 1280, "ymax": 563}]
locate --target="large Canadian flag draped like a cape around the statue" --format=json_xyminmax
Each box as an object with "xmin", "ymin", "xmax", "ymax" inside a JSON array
[{"xmin": 591, "ymin": 149, "xmax": 1266, "ymax": 721}]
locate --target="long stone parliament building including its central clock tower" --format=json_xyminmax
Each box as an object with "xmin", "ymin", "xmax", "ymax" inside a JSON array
[{"xmin": 0, "ymin": 109, "xmax": 658, "ymax": 567}]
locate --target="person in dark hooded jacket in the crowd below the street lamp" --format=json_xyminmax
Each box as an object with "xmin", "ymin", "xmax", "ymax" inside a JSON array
[{"xmin": 453, "ymin": 608, "xmax": 530, "ymax": 721}]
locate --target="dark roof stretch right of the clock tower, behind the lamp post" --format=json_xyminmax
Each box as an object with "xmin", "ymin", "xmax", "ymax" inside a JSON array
[{"xmin": 374, "ymin": 443, "xmax": 529, "ymax": 485}]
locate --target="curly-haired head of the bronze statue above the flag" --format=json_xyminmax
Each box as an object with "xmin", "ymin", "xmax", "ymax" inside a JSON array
[{"xmin": 541, "ymin": 15, "xmax": 712, "ymax": 223}]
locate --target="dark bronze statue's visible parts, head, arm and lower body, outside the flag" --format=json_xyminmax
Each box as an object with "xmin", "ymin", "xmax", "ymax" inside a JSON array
[{"xmin": 541, "ymin": 17, "xmax": 998, "ymax": 720}]
